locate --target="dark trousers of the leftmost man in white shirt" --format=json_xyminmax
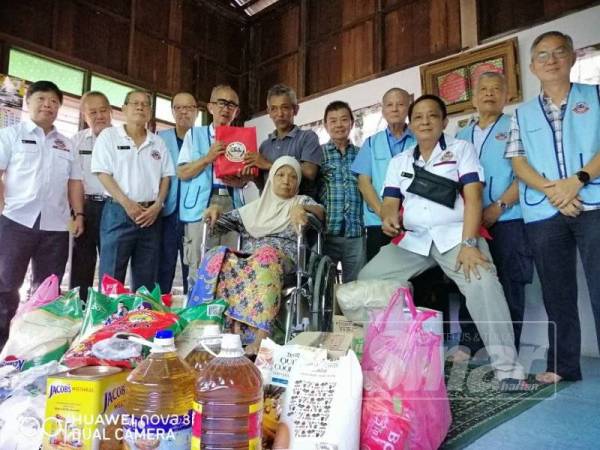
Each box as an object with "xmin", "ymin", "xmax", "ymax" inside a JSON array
[{"xmin": 0, "ymin": 216, "xmax": 69, "ymax": 347}]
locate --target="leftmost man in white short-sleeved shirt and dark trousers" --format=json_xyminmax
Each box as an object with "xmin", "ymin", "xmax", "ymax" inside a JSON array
[{"xmin": 0, "ymin": 81, "xmax": 84, "ymax": 346}]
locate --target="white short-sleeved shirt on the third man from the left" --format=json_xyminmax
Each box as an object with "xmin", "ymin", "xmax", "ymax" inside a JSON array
[{"xmin": 91, "ymin": 125, "xmax": 175, "ymax": 202}]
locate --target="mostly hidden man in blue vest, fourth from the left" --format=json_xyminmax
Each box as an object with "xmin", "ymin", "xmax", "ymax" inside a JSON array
[{"xmin": 158, "ymin": 92, "xmax": 198, "ymax": 293}]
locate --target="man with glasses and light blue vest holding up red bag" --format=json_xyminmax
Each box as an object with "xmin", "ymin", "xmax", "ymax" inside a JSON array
[{"xmin": 177, "ymin": 85, "xmax": 256, "ymax": 286}]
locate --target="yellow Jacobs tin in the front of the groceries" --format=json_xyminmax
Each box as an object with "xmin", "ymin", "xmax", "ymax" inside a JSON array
[{"xmin": 42, "ymin": 366, "xmax": 129, "ymax": 450}]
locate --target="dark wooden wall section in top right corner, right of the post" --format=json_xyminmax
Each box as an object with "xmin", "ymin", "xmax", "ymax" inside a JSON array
[{"xmin": 477, "ymin": 0, "xmax": 600, "ymax": 40}]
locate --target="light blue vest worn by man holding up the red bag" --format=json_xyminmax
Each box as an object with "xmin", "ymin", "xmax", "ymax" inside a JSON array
[{"xmin": 179, "ymin": 126, "xmax": 243, "ymax": 222}]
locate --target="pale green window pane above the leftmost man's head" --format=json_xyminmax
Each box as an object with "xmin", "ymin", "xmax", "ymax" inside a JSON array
[{"xmin": 8, "ymin": 48, "xmax": 85, "ymax": 95}]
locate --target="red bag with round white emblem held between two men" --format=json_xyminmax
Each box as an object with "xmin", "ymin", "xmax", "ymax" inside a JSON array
[{"xmin": 214, "ymin": 126, "xmax": 258, "ymax": 178}]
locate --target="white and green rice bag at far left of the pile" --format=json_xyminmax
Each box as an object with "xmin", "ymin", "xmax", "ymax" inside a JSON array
[{"xmin": 0, "ymin": 289, "xmax": 83, "ymax": 370}]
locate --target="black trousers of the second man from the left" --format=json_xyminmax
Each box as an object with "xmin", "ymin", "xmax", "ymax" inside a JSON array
[{"xmin": 69, "ymin": 199, "xmax": 104, "ymax": 300}]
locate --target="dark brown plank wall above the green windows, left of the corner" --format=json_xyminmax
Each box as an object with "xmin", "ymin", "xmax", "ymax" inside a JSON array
[{"xmin": 0, "ymin": 0, "xmax": 248, "ymax": 110}]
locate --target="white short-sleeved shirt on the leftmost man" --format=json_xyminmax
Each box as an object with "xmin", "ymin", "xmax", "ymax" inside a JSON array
[{"xmin": 0, "ymin": 120, "xmax": 81, "ymax": 231}]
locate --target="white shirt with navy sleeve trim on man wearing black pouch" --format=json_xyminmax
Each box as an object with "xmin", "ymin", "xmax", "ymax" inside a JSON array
[{"xmin": 384, "ymin": 135, "xmax": 484, "ymax": 256}]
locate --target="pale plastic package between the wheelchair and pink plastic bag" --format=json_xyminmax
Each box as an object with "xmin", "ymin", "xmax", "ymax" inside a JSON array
[{"xmin": 336, "ymin": 280, "xmax": 400, "ymax": 324}]
